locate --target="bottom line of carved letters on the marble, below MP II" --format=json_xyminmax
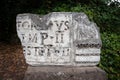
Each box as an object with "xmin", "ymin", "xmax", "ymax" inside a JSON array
[{"xmin": 23, "ymin": 46, "xmax": 70, "ymax": 57}]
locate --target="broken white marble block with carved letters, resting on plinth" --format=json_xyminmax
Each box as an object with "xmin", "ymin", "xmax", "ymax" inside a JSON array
[{"xmin": 16, "ymin": 12, "xmax": 101, "ymax": 66}]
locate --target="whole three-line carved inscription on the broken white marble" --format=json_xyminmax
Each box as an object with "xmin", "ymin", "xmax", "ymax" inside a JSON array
[{"xmin": 18, "ymin": 20, "xmax": 70, "ymax": 62}]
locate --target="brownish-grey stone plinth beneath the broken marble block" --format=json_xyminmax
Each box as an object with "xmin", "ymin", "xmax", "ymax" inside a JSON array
[{"xmin": 24, "ymin": 66, "xmax": 107, "ymax": 80}]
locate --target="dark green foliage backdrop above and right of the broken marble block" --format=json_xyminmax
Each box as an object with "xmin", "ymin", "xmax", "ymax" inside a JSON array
[{"xmin": 0, "ymin": 0, "xmax": 120, "ymax": 80}]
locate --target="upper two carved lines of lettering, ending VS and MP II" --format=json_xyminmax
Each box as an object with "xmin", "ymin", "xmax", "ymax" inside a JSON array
[{"xmin": 18, "ymin": 20, "xmax": 69, "ymax": 45}]
